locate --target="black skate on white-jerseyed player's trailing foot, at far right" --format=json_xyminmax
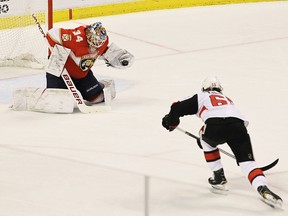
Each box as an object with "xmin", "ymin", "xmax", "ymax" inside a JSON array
[{"xmin": 257, "ymin": 185, "xmax": 283, "ymax": 208}]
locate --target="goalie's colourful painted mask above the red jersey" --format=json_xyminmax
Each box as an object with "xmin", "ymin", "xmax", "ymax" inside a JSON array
[{"xmin": 86, "ymin": 22, "xmax": 107, "ymax": 48}]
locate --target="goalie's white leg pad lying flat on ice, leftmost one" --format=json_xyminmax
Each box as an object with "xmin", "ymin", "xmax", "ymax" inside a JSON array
[{"xmin": 12, "ymin": 87, "xmax": 74, "ymax": 113}]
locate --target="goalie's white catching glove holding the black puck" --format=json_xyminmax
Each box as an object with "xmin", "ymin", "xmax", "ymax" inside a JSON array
[{"xmin": 102, "ymin": 43, "xmax": 134, "ymax": 69}]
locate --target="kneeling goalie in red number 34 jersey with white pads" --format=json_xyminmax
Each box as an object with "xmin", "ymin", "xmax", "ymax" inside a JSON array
[{"xmin": 12, "ymin": 22, "xmax": 134, "ymax": 113}]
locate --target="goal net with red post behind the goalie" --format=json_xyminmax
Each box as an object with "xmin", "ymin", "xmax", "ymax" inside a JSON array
[{"xmin": 0, "ymin": 0, "xmax": 53, "ymax": 68}]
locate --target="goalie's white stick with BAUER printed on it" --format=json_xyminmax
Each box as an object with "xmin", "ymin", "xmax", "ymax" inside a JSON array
[{"xmin": 32, "ymin": 14, "xmax": 111, "ymax": 113}]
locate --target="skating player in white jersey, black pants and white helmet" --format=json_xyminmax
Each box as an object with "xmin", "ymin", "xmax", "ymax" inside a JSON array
[{"xmin": 162, "ymin": 77, "xmax": 282, "ymax": 207}]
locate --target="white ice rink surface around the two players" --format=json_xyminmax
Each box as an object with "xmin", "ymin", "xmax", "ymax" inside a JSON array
[{"xmin": 0, "ymin": 2, "xmax": 288, "ymax": 216}]
